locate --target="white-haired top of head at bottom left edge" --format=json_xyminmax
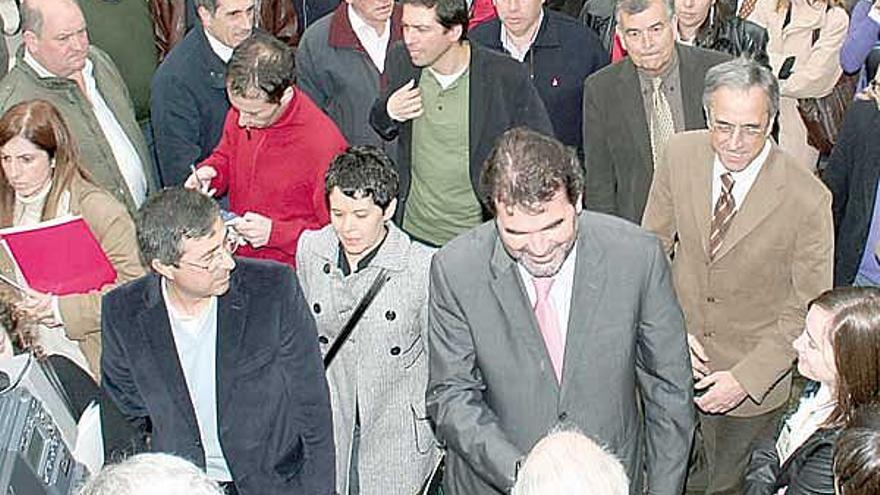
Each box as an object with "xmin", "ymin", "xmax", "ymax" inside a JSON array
[{"xmin": 79, "ymin": 453, "xmax": 223, "ymax": 495}]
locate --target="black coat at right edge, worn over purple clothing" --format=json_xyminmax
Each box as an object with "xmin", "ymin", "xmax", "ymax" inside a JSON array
[{"xmin": 822, "ymin": 101, "xmax": 880, "ymax": 286}]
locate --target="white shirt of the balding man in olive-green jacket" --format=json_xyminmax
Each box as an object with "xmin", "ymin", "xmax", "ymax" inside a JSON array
[{"xmin": 24, "ymin": 50, "xmax": 147, "ymax": 206}]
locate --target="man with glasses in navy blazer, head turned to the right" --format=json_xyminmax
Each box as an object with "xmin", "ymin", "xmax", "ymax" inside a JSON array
[{"xmin": 101, "ymin": 188, "xmax": 335, "ymax": 495}]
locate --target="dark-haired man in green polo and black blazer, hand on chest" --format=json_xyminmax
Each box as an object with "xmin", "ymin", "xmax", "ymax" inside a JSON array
[{"xmin": 370, "ymin": 0, "xmax": 553, "ymax": 246}]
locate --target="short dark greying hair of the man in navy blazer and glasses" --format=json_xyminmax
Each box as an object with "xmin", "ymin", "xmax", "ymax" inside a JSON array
[{"xmin": 135, "ymin": 187, "xmax": 220, "ymax": 267}]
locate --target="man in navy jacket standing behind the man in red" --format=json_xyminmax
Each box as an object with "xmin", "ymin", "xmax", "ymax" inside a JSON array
[{"xmin": 150, "ymin": 0, "xmax": 254, "ymax": 187}]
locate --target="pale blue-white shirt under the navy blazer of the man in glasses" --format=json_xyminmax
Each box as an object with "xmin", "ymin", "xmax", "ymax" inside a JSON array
[{"xmin": 162, "ymin": 279, "xmax": 232, "ymax": 482}]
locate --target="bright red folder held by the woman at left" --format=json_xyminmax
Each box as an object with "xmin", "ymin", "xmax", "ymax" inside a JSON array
[{"xmin": 0, "ymin": 216, "xmax": 116, "ymax": 296}]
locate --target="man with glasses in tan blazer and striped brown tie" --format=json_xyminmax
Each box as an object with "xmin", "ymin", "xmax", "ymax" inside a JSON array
[{"xmin": 642, "ymin": 59, "xmax": 833, "ymax": 493}]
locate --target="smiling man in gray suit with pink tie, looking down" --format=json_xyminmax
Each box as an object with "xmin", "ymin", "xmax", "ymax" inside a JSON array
[{"xmin": 427, "ymin": 128, "xmax": 694, "ymax": 495}]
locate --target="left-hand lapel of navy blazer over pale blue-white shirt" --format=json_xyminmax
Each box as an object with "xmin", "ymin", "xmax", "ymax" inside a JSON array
[{"xmin": 138, "ymin": 280, "xmax": 198, "ymax": 431}]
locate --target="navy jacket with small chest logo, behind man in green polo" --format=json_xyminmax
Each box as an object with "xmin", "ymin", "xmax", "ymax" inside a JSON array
[{"xmin": 468, "ymin": 9, "xmax": 609, "ymax": 149}]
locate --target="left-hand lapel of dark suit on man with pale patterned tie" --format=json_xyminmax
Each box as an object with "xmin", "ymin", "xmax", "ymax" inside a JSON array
[{"xmin": 620, "ymin": 59, "xmax": 654, "ymax": 177}]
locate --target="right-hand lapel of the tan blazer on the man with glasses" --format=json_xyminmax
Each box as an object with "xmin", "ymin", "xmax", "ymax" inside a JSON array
[{"xmin": 715, "ymin": 145, "xmax": 785, "ymax": 261}]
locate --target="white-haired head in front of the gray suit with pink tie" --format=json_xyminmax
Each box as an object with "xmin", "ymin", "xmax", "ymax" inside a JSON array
[{"xmin": 511, "ymin": 428, "xmax": 629, "ymax": 495}]
